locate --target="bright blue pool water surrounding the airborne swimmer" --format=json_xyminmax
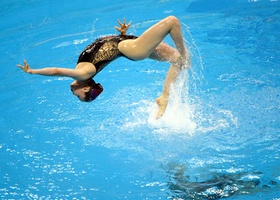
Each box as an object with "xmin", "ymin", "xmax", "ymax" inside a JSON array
[{"xmin": 0, "ymin": 0, "xmax": 280, "ymax": 200}]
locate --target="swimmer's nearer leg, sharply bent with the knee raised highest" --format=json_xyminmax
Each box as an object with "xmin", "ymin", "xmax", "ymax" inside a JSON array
[{"xmin": 118, "ymin": 16, "xmax": 188, "ymax": 60}]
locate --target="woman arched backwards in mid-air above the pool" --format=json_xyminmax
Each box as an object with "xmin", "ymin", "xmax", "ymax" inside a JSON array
[{"xmin": 17, "ymin": 16, "xmax": 189, "ymax": 118}]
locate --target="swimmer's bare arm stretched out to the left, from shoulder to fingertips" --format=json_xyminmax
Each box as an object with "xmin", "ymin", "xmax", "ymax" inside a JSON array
[{"xmin": 17, "ymin": 60, "xmax": 96, "ymax": 80}]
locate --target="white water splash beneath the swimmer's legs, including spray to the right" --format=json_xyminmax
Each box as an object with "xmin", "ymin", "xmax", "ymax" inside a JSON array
[{"xmin": 118, "ymin": 71, "xmax": 238, "ymax": 135}]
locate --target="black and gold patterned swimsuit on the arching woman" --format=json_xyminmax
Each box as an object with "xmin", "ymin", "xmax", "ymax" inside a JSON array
[{"xmin": 77, "ymin": 35, "xmax": 137, "ymax": 74}]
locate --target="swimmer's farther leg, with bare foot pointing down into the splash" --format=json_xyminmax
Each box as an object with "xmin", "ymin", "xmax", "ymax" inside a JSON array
[{"xmin": 150, "ymin": 43, "xmax": 189, "ymax": 119}]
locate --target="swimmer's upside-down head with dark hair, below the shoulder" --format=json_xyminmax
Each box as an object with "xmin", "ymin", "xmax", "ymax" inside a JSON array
[{"xmin": 71, "ymin": 79, "xmax": 103, "ymax": 102}]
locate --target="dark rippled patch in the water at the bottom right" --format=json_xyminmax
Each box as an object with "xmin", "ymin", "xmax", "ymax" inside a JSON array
[{"xmin": 166, "ymin": 163, "xmax": 280, "ymax": 200}]
